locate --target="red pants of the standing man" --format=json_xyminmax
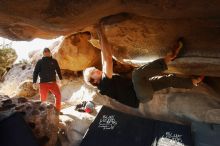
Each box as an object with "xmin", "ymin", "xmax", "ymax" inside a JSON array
[{"xmin": 40, "ymin": 82, "xmax": 61, "ymax": 111}]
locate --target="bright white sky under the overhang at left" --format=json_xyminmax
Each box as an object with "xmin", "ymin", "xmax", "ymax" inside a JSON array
[{"xmin": 0, "ymin": 37, "xmax": 60, "ymax": 62}]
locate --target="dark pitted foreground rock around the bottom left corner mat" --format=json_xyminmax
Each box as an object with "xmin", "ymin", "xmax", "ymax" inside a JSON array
[{"xmin": 0, "ymin": 98, "xmax": 59, "ymax": 146}]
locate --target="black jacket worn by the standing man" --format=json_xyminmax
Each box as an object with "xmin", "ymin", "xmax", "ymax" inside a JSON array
[{"xmin": 33, "ymin": 57, "xmax": 62, "ymax": 83}]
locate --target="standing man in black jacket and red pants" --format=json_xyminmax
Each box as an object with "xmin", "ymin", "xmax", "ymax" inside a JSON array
[{"xmin": 33, "ymin": 48, "xmax": 62, "ymax": 112}]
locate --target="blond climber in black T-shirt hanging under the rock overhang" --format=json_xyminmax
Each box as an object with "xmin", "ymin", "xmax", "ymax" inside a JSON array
[{"xmin": 84, "ymin": 24, "xmax": 203, "ymax": 108}]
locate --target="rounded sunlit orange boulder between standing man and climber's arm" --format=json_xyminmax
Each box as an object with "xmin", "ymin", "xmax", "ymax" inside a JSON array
[{"xmin": 53, "ymin": 32, "xmax": 101, "ymax": 71}]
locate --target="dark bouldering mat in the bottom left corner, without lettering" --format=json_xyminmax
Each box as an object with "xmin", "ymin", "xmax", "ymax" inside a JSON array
[{"xmin": 0, "ymin": 113, "xmax": 38, "ymax": 146}]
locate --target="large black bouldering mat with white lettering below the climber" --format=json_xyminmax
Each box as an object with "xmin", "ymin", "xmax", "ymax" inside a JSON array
[{"xmin": 80, "ymin": 106, "xmax": 192, "ymax": 146}]
